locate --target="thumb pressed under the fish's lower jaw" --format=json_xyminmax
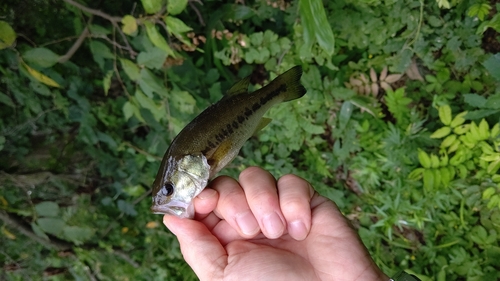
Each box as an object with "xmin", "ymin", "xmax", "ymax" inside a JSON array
[{"xmin": 163, "ymin": 215, "xmax": 227, "ymax": 280}]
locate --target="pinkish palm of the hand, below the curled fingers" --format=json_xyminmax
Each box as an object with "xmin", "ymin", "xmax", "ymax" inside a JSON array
[{"xmin": 213, "ymin": 200, "xmax": 380, "ymax": 280}]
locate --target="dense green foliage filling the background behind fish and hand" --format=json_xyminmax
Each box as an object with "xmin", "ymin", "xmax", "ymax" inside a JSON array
[{"xmin": 0, "ymin": 0, "xmax": 500, "ymax": 280}]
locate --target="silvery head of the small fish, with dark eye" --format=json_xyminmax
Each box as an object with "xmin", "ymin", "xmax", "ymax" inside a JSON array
[{"xmin": 151, "ymin": 153, "xmax": 210, "ymax": 218}]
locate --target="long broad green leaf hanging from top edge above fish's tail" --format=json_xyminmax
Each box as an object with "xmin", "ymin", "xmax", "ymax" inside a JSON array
[{"xmin": 299, "ymin": 0, "xmax": 335, "ymax": 56}]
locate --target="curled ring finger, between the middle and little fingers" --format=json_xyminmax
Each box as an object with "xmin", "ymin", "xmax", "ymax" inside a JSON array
[{"xmin": 240, "ymin": 167, "xmax": 285, "ymax": 239}]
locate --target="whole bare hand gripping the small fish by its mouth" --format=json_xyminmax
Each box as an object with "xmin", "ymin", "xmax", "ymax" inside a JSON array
[{"xmin": 163, "ymin": 167, "xmax": 389, "ymax": 281}]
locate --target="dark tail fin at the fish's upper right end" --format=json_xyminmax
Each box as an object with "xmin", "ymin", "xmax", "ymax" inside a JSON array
[{"xmin": 268, "ymin": 65, "xmax": 307, "ymax": 101}]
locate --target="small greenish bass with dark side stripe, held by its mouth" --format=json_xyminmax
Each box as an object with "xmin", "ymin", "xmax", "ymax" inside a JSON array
[{"xmin": 151, "ymin": 66, "xmax": 306, "ymax": 218}]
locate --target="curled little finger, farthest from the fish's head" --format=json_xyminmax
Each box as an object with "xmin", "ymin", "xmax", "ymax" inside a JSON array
[{"xmin": 277, "ymin": 175, "xmax": 314, "ymax": 240}]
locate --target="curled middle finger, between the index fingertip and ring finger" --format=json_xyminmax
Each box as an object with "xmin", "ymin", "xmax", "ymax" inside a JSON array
[{"xmin": 211, "ymin": 176, "xmax": 260, "ymax": 238}]
